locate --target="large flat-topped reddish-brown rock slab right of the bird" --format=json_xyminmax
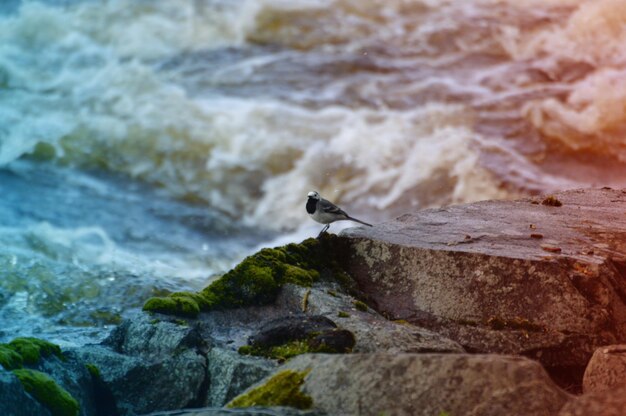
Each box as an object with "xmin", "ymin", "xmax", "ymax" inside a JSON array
[{"xmin": 339, "ymin": 189, "xmax": 626, "ymax": 384}]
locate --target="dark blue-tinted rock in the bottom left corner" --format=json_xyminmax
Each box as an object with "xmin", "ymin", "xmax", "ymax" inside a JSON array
[{"xmin": 0, "ymin": 367, "xmax": 50, "ymax": 416}]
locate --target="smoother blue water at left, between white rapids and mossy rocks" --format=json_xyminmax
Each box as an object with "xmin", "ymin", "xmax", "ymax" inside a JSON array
[{"xmin": 0, "ymin": 160, "xmax": 269, "ymax": 344}]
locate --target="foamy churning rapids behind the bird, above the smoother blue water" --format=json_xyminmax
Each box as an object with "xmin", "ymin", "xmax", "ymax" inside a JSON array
[{"xmin": 0, "ymin": 0, "xmax": 626, "ymax": 229}]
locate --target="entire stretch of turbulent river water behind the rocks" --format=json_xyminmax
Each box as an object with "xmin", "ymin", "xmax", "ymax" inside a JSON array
[{"xmin": 0, "ymin": 0, "xmax": 626, "ymax": 343}]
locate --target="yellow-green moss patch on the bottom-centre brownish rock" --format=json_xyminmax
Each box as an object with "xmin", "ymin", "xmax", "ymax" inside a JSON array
[{"xmin": 226, "ymin": 370, "xmax": 313, "ymax": 409}]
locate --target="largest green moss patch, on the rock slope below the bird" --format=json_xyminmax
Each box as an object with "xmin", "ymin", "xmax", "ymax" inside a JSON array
[{"xmin": 143, "ymin": 237, "xmax": 346, "ymax": 317}]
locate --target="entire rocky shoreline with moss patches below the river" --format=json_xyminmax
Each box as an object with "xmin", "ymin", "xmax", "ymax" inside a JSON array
[{"xmin": 0, "ymin": 188, "xmax": 626, "ymax": 416}]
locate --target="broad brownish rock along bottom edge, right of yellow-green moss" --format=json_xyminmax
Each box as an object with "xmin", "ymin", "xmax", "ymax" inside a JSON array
[{"xmin": 280, "ymin": 354, "xmax": 572, "ymax": 416}]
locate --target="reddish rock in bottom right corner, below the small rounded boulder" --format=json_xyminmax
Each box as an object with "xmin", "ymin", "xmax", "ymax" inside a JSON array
[{"xmin": 558, "ymin": 387, "xmax": 626, "ymax": 416}]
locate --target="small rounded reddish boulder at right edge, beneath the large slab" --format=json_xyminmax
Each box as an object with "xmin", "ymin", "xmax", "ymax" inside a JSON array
[{"xmin": 583, "ymin": 345, "xmax": 626, "ymax": 393}]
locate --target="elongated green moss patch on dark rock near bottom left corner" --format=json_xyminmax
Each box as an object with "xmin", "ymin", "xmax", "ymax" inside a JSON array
[{"xmin": 13, "ymin": 369, "xmax": 79, "ymax": 416}]
